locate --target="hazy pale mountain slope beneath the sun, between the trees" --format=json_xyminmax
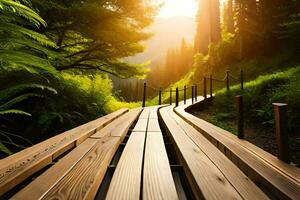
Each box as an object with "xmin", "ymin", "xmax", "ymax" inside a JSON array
[{"xmin": 129, "ymin": 16, "xmax": 196, "ymax": 63}]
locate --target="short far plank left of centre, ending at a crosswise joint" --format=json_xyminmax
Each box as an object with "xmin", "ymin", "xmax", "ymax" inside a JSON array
[{"xmin": 90, "ymin": 108, "xmax": 142, "ymax": 138}]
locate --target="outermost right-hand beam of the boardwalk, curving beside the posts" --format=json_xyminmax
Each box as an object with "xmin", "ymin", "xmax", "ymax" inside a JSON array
[{"xmin": 175, "ymin": 104, "xmax": 300, "ymax": 199}]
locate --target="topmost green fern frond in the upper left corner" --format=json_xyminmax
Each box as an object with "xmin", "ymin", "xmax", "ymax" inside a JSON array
[{"xmin": 0, "ymin": 0, "xmax": 47, "ymax": 27}]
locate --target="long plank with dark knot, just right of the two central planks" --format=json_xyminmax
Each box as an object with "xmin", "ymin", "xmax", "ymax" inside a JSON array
[{"xmin": 160, "ymin": 107, "xmax": 242, "ymax": 199}]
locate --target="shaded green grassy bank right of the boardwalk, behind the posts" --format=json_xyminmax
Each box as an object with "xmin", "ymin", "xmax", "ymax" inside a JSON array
[{"xmin": 192, "ymin": 66, "xmax": 300, "ymax": 164}]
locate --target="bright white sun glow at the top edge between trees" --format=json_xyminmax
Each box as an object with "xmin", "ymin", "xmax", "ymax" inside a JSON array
[{"xmin": 158, "ymin": 0, "xmax": 198, "ymax": 18}]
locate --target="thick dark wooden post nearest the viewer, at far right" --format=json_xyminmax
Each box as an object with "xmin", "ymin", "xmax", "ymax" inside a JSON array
[{"xmin": 273, "ymin": 103, "xmax": 290, "ymax": 163}]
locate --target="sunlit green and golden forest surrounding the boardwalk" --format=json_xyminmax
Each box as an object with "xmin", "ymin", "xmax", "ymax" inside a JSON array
[{"xmin": 0, "ymin": 0, "xmax": 300, "ymax": 161}]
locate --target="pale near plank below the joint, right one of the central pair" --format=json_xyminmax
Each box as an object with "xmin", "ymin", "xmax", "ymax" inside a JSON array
[{"xmin": 143, "ymin": 132, "xmax": 178, "ymax": 200}]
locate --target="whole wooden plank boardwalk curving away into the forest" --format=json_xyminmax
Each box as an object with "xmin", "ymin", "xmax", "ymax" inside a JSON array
[{"xmin": 0, "ymin": 97, "xmax": 300, "ymax": 200}]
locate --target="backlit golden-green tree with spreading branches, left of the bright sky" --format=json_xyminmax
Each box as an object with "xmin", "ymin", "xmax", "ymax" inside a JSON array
[{"xmin": 33, "ymin": 0, "xmax": 157, "ymax": 78}]
